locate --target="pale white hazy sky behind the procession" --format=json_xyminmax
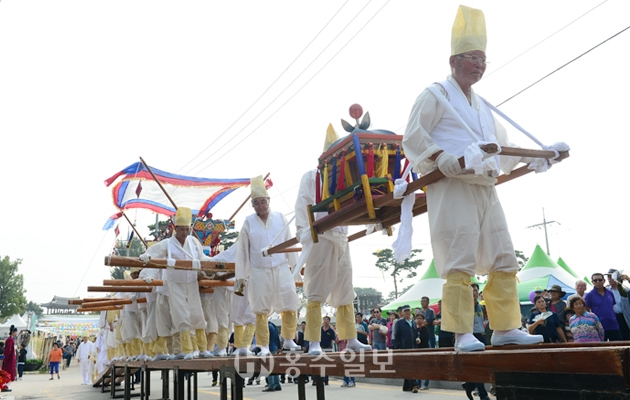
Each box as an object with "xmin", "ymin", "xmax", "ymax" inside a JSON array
[{"xmin": 0, "ymin": 0, "xmax": 630, "ymax": 302}]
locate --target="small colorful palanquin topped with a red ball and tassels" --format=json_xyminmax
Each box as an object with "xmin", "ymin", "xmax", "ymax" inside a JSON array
[{"xmin": 311, "ymin": 104, "xmax": 417, "ymax": 225}]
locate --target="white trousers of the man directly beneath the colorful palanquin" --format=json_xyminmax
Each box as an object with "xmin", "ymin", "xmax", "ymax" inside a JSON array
[{"xmin": 304, "ymin": 232, "xmax": 356, "ymax": 307}]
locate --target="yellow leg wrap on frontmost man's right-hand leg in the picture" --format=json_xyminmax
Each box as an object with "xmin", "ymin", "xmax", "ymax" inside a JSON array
[{"xmin": 483, "ymin": 271, "xmax": 521, "ymax": 331}]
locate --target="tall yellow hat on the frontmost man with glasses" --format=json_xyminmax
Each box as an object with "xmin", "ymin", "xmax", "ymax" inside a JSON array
[{"xmin": 451, "ymin": 6, "xmax": 488, "ymax": 56}]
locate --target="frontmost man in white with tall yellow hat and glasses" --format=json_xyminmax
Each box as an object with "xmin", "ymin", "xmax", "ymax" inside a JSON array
[{"xmin": 403, "ymin": 6, "xmax": 568, "ymax": 351}]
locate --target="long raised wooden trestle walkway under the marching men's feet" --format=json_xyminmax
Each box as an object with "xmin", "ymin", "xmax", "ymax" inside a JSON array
[{"xmin": 109, "ymin": 342, "xmax": 630, "ymax": 400}]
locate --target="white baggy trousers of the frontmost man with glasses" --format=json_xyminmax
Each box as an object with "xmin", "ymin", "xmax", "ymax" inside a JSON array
[{"xmin": 427, "ymin": 178, "xmax": 518, "ymax": 279}]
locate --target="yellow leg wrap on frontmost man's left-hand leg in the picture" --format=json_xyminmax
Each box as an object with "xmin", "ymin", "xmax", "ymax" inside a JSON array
[{"xmin": 442, "ymin": 272, "xmax": 476, "ymax": 333}]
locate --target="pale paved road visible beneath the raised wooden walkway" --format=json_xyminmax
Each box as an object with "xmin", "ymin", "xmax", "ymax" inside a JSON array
[{"xmin": 4, "ymin": 360, "xmax": 478, "ymax": 400}]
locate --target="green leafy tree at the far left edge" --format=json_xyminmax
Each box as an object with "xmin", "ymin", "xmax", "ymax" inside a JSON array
[{"xmin": 0, "ymin": 256, "xmax": 26, "ymax": 320}]
